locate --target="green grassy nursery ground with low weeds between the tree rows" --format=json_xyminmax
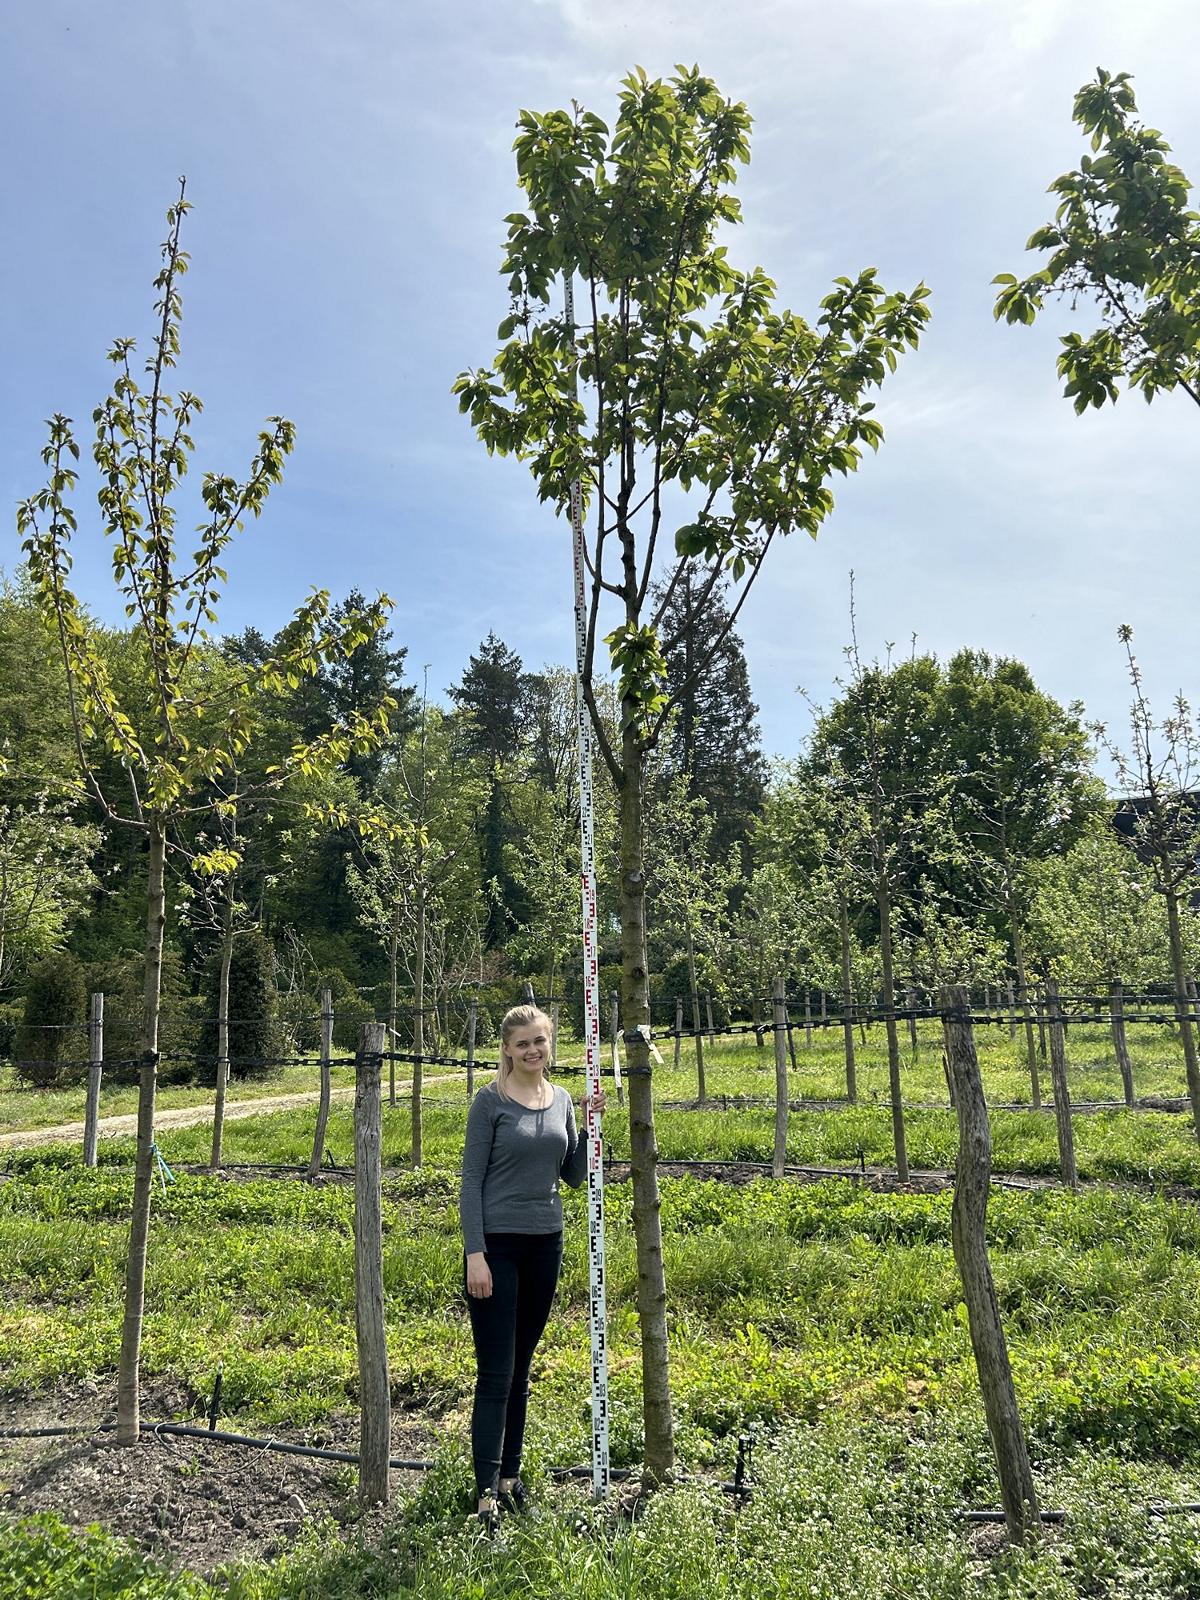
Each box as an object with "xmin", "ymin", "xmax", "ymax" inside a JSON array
[{"xmin": 0, "ymin": 1026, "xmax": 1200, "ymax": 1600}]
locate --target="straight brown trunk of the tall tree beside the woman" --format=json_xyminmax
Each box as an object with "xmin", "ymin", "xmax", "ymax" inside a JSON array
[{"xmin": 621, "ymin": 736, "xmax": 678, "ymax": 1485}]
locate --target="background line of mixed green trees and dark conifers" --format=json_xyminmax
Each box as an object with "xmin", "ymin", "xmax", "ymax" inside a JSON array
[{"xmin": 0, "ymin": 556, "xmax": 1200, "ymax": 1070}]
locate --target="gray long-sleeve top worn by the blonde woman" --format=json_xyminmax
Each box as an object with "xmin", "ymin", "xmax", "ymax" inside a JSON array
[{"xmin": 459, "ymin": 1082, "xmax": 587, "ymax": 1256}]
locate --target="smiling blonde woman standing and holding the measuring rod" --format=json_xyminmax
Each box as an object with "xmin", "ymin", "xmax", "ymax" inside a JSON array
[{"xmin": 459, "ymin": 1005, "xmax": 605, "ymax": 1531}]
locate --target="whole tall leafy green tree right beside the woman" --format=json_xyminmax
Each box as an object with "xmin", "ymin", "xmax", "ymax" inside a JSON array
[{"xmin": 454, "ymin": 69, "xmax": 928, "ymax": 1482}]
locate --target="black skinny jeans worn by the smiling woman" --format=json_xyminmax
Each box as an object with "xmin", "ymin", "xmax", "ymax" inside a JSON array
[{"xmin": 464, "ymin": 1234, "xmax": 563, "ymax": 1494}]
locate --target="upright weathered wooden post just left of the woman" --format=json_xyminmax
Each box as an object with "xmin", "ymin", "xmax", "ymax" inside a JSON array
[{"xmin": 354, "ymin": 1022, "xmax": 392, "ymax": 1506}]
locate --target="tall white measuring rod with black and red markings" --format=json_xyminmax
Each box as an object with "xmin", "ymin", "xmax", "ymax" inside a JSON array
[{"xmin": 563, "ymin": 270, "xmax": 608, "ymax": 1499}]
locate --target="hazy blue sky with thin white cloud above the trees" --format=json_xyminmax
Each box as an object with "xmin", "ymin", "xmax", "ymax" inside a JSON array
[{"xmin": 0, "ymin": 0, "xmax": 1200, "ymax": 755}]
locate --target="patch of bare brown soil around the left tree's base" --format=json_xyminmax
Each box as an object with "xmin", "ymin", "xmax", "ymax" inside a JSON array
[{"xmin": 0, "ymin": 1379, "xmax": 437, "ymax": 1573}]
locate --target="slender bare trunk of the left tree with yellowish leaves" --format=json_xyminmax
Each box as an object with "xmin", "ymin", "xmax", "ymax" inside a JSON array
[{"xmin": 117, "ymin": 813, "xmax": 166, "ymax": 1445}]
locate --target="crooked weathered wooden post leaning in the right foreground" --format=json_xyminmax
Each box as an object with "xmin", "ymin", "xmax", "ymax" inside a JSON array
[{"xmin": 941, "ymin": 986, "xmax": 1042, "ymax": 1544}]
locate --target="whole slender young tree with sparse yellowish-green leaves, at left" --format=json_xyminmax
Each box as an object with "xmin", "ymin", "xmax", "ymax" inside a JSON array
[{"xmin": 18, "ymin": 182, "xmax": 395, "ymax": 1443}]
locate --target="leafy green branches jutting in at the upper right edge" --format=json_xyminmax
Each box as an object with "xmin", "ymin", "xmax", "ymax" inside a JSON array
[{"xmin": 994, "ymin": 70, "xmax": 1200, "ymax": 411}]
